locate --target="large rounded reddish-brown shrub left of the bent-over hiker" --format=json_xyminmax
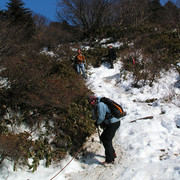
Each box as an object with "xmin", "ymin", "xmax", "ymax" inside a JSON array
[{"xmin": 0, "ymin": 49, "xmax": 93, "ymax": 171}]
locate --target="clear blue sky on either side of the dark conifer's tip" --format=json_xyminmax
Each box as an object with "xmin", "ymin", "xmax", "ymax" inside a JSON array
[{"xmin": 0, "ymin": 0, "xmax": 56, "ymax": 21}]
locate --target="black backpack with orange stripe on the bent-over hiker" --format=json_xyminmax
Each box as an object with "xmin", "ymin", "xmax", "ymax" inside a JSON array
[{"xmin": 100, "ymin": 97, "xmax": 125, "ymax": 118}]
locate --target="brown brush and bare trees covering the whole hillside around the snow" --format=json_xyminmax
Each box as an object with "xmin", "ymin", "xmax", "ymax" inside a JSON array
[{"xmin": 0, "ymin": 0, "xmax": 180, "ymax": 171}]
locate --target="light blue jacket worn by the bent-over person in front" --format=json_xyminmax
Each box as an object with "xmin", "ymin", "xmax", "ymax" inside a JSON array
[{"xmin": 93, "ymin": 98, "xmax": 120, "ymax": 124}]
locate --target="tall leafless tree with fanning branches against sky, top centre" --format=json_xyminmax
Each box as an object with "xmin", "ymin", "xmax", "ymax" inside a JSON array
[{"xmin": 57, "ymin": 0, "xmax": 114, "ymax": 39}]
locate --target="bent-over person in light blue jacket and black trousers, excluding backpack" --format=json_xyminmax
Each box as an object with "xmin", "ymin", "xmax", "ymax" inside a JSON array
[{"xmin": 88, "ymin": 94, "xmax": 120, "ymax": 164}]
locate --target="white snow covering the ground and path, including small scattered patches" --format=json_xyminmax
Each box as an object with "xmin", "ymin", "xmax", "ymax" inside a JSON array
[{"xmin": 0, "ymin": 41, "xmax": 180, "ymax": 180}]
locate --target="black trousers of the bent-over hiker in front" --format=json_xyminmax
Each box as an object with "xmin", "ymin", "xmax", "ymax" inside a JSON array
[{"xmin": 100, "ymin": 121, "xmax": 120, "ymax": 162}]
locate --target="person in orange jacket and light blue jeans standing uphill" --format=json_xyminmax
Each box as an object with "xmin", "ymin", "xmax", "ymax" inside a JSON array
[{"xmin": 75, "ymin": 49, "xmax": 86, "ymax": 78}]
